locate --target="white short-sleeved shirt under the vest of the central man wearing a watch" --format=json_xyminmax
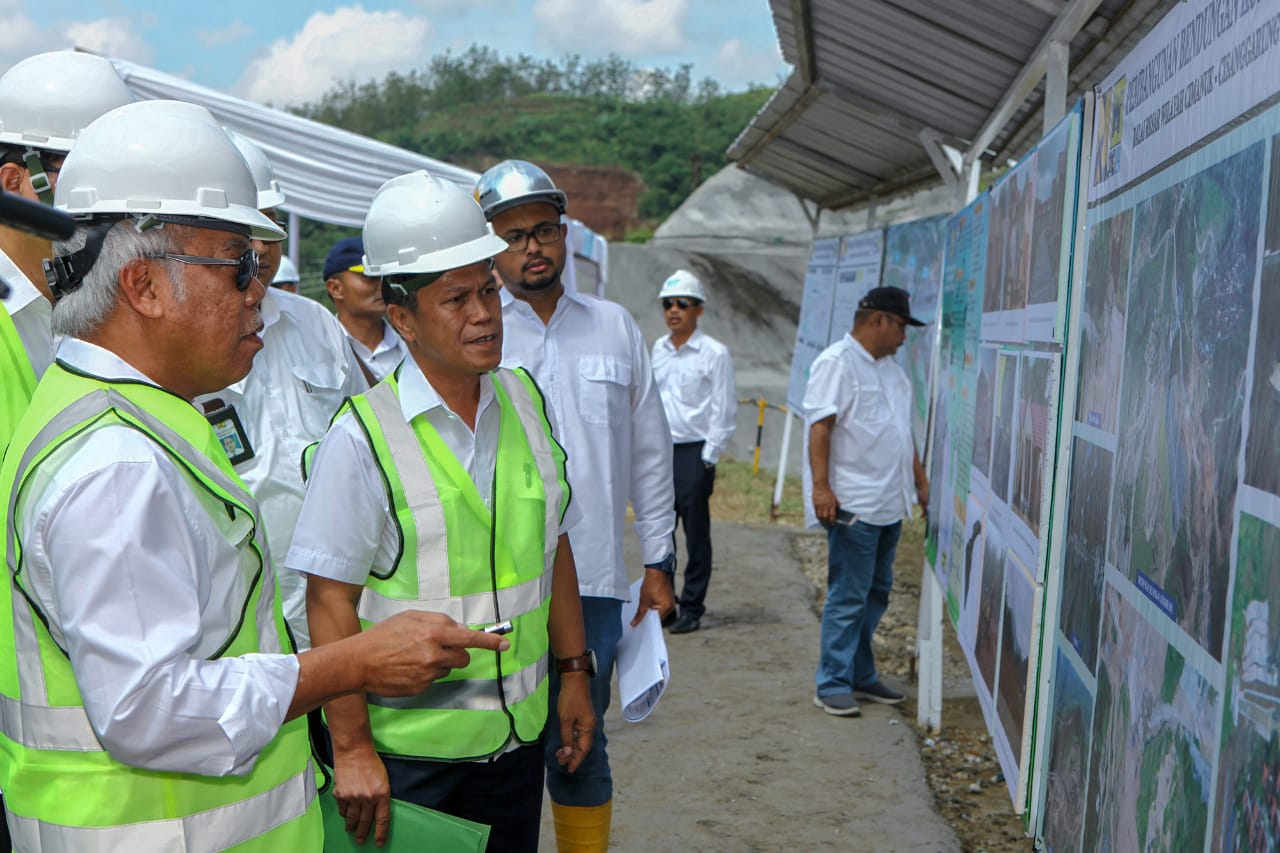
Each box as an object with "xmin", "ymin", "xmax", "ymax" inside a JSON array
[{"xmin": 284, "ymin": 359, "xmax": 577, "ymax": 585}]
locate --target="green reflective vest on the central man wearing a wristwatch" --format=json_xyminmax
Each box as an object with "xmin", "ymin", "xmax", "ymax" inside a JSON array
[{"xmin": 317, "ymin": 369, "xmax": 570, "ymax": 761}]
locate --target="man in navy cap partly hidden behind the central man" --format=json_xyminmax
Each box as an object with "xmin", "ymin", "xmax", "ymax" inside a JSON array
[{"xmin": 324, "ymin": 237, "xmax": 408, "ymax": 376}]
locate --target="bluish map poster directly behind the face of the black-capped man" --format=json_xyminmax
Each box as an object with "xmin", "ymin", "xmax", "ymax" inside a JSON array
[{"xmin": 881, "ymin": 216, "xmax": 947, "ymax": 452}]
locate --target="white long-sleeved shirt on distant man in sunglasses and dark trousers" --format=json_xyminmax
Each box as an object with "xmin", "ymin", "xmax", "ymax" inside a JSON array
[{"xmin": 653, "ymin": 329, "xmax": 737, "ymax": 465}]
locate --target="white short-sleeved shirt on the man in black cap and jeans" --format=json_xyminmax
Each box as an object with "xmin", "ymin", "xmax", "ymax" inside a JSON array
[{"xmin": 804, "ymin": 334, "xmax": 915, "ymax": 528}]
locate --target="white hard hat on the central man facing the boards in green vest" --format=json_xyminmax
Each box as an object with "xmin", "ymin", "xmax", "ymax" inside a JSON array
[{"xmin": 364, "ymin": 170, "xmax": 507, "ymax": 275}]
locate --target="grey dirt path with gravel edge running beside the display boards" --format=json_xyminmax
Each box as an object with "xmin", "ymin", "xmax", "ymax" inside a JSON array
[{"xmin": 541, "ymin": 502, "xmax": 1032, "ymax": 853}]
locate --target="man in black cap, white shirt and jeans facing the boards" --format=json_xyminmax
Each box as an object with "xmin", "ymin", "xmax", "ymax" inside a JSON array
[{"xmin": 804, "ymin": 287, "xmax": 929, "ymax": 717}]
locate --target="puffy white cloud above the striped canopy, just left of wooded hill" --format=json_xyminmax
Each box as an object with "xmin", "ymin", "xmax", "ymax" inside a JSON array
[{"xmin": 237, "ymin": 6, "xmax": 431, "ymax": 104}]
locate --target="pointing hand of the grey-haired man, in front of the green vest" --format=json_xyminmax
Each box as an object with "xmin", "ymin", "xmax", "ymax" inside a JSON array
[{"xmin": 360, "ymin": 611, "xmax": 511, "ymax": 695}]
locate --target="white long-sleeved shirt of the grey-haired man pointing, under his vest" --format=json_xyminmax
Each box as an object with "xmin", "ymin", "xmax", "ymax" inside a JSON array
[{"xmin": 17, "ymin": 338, "xmax": 298, "ymax": 776}]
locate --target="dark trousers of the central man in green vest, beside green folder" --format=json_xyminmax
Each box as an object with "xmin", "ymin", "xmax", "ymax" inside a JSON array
[{"xmin": 381, "ymin": 743, "xmax": 543, "ymax": 853}]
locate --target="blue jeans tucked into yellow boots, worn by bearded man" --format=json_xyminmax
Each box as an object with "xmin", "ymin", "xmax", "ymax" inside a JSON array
[{"xmin": 543, "ymin": 596, "xmax": 622, "ymax": 806}]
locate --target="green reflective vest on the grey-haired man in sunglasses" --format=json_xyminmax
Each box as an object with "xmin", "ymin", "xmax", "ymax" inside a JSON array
[{"xmin": 0, "ymin": 364, "xmax": 324, "ymax": 853}]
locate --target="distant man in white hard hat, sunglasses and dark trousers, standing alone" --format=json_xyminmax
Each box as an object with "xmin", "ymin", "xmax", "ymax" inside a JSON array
[{"xmin": 653, "ymin": 269, "xmax": 737, "ymax": 634}]
